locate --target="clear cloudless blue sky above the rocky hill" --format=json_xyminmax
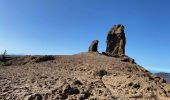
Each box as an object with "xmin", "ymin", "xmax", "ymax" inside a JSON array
[{"xmin": 0, "ymin": 0, "xmax": 170, "ymax": 72}]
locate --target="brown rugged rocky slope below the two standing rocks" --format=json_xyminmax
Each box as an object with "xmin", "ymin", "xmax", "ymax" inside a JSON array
[{"xmin": 0, "ymin": 53, "xmax": 170, "ymax": 100}]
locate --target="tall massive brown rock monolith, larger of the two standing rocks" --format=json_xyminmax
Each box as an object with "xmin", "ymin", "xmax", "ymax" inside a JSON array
[{"xmin": 106, "ymin": 24, "xmax": 126, "ymax": 56}]
